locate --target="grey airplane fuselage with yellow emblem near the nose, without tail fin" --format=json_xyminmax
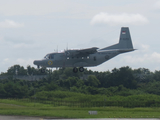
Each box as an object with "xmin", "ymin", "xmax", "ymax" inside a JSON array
[{"xmin": 34, "ymin": 50, "xmax": 132, "ymax": 68}]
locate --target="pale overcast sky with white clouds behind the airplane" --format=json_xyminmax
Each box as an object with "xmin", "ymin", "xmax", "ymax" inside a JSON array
[{"xmin": 0, "ymin": 0, "xmax": 160, "ymax": 72}]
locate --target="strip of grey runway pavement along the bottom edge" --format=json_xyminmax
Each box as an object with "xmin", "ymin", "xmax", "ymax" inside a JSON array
[{"xmin": 0, "ymin": 115, "xmax": 160, "ymax": 120}]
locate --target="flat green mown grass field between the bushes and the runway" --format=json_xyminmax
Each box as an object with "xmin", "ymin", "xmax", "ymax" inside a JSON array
[{"xmin": 0, "ymin": 99, "xmax": 160, "ymax": 118}]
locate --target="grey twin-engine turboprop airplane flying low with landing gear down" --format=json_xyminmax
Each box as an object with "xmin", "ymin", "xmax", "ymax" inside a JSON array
[{"xmin": 34, "ymin": 27, "xmax": 135, "ymax": 73}]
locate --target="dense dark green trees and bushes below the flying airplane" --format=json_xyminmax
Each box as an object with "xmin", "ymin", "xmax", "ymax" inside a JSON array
[{"xmin": 0, "ymin": 65, "xmax": 160, "ymax": 100}]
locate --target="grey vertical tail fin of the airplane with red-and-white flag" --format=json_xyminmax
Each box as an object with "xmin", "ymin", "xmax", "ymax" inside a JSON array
[{"xmin": 101, "ymin": 27, "xmax": 133, "ymax": 50}]
